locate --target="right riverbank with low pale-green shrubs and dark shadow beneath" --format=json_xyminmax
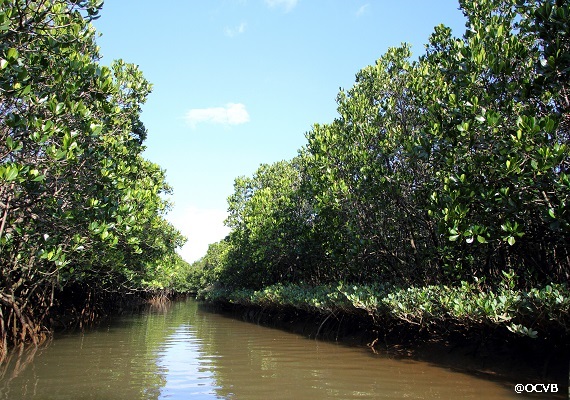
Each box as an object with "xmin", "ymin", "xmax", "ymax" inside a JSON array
[{"xmin": 200, "ymin": 284, "xmax": 570, "ymax": 393}]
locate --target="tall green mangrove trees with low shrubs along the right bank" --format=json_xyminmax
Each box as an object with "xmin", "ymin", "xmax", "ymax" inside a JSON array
[{"xmin": 192, "ymin": 0, "xmax": 570, "ymax": 338}]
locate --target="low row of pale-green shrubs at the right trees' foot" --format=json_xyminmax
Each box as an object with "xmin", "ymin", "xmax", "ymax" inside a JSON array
[{"xmin": 204, "ymin": 280, "xmax": 570, "ymax": 343}]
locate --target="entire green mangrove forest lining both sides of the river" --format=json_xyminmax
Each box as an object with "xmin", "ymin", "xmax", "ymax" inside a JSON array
[{"xmin": 0, "ymin": 0, "xmax": 570, "ymax": 372}]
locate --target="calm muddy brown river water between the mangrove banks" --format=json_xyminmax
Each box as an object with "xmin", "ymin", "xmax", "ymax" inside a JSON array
[{"xmin": 0, "ymin": 300, "xmax": 552, "ymax": 400}]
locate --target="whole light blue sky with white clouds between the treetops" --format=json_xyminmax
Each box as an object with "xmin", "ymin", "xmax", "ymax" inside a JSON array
[{"xmin": 94, "ymin": 0, "xmax": 465, "ymax": 261}]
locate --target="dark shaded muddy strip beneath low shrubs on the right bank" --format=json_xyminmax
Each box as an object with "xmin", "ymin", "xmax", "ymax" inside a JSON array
[{"xmin": 202, "ymin": 303, "xmax": 570, "ymax": 398}]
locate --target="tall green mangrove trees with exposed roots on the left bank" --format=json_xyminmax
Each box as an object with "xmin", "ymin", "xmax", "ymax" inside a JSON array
[{"xmin": 0, "ymin": 0, "xmax": 192, "ymax": 360}]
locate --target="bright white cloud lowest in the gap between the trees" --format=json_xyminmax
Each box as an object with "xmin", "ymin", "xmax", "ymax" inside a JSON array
[{"xmin": 168, "ymin": 207, "xmax": 230, "ymax": 262}]
